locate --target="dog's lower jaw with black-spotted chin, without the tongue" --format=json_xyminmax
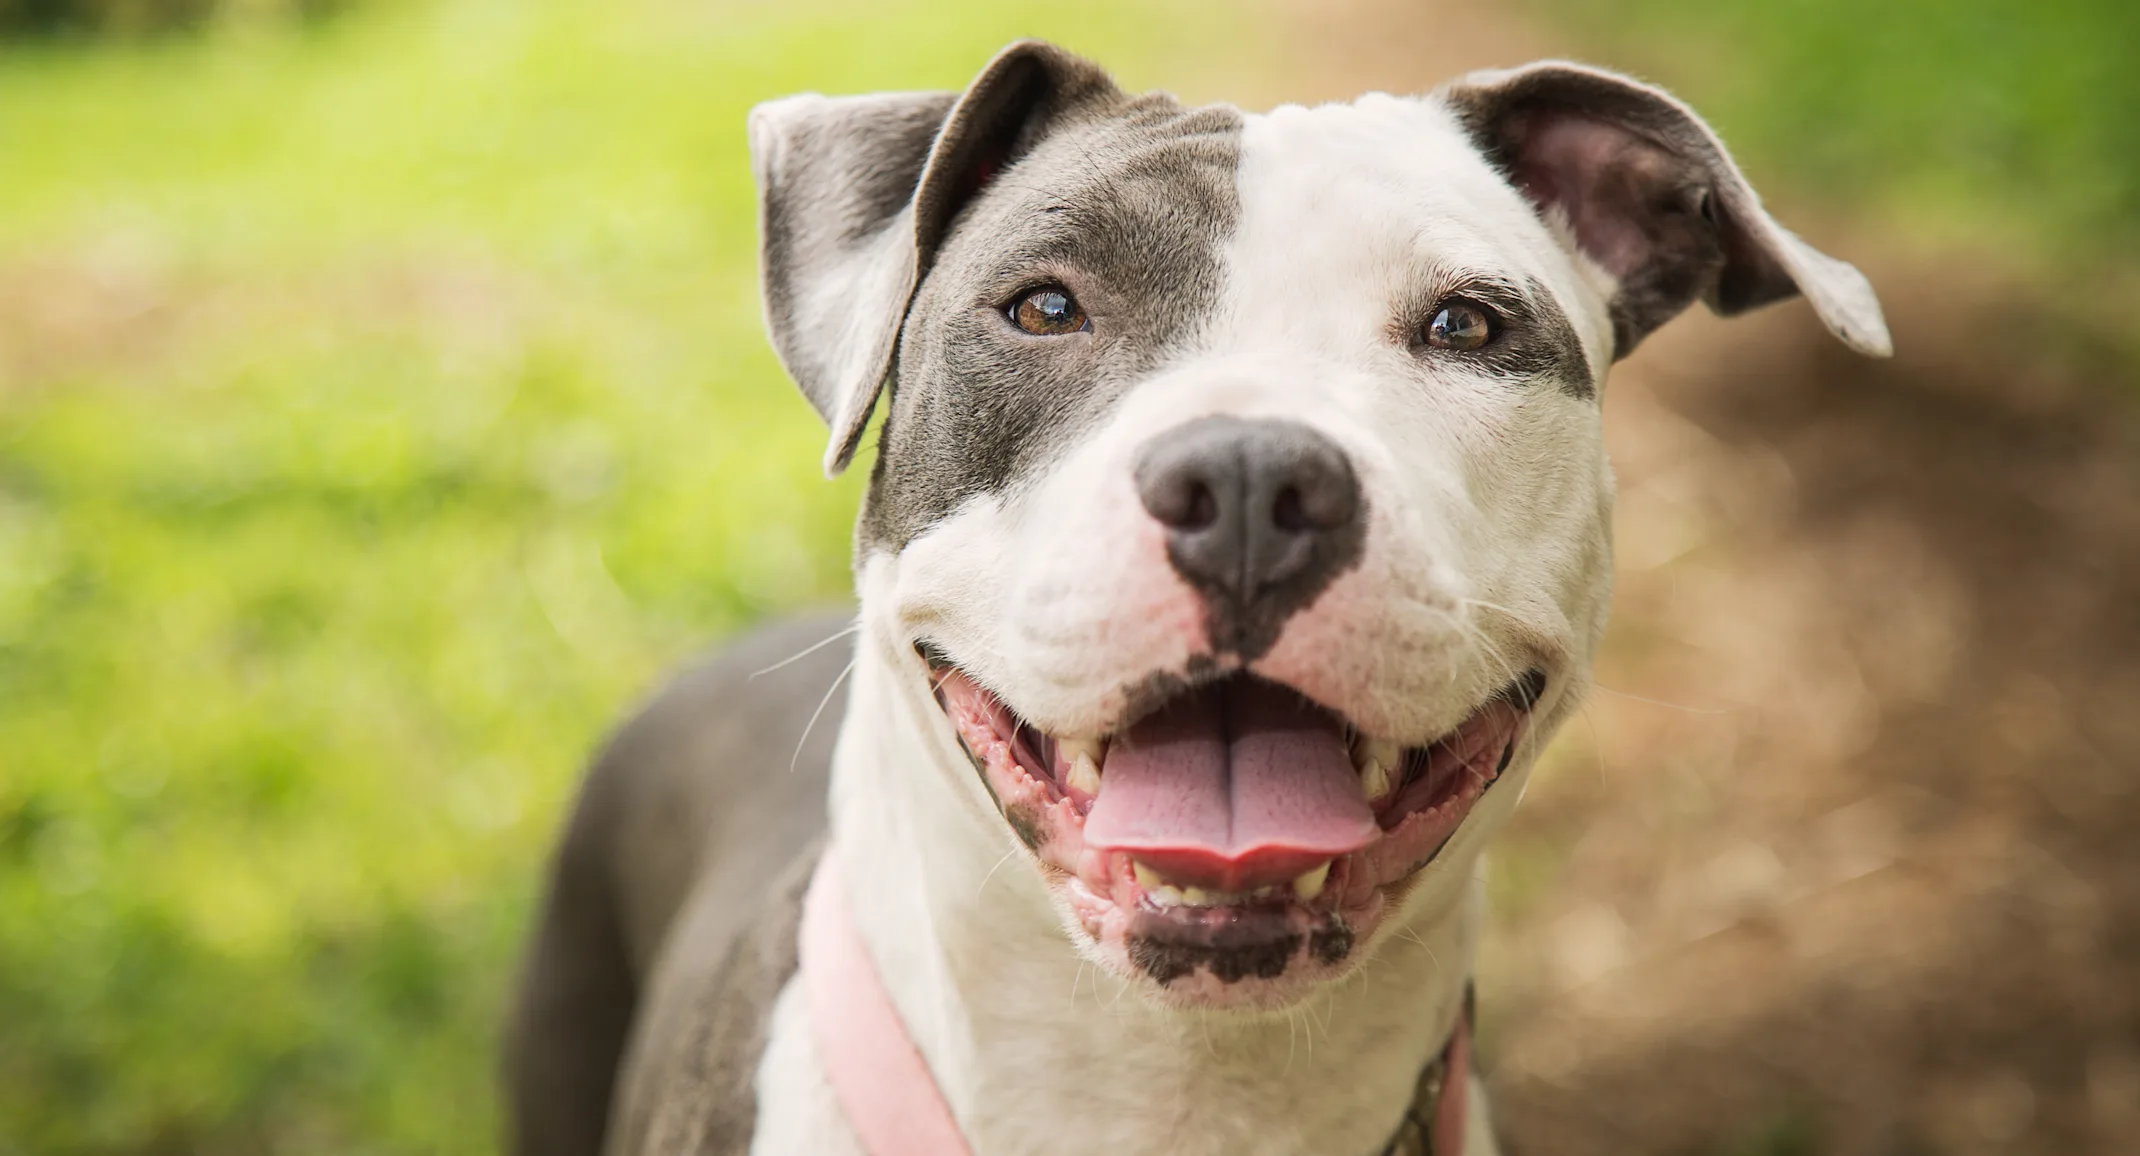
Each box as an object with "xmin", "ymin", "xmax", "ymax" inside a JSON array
[{"xmin": 929, "ymin": 655, "xmax": 1545, "ymax": 1008}]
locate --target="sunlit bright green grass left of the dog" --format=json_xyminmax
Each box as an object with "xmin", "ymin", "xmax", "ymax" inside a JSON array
[{"xmin": 0, "ymin": 0, "xmax": 1258, "ymax": 1156}]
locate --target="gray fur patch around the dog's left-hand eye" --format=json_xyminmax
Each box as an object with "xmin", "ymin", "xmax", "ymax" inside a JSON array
[{"xmin": 858, "ymin": 94, "xmax": 1241, "ymax": 552}]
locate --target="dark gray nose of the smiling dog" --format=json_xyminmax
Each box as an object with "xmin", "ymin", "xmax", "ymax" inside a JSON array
[{"xmin": 1136, "ymin": 417, "xmax": 1367, "ymax": 659}]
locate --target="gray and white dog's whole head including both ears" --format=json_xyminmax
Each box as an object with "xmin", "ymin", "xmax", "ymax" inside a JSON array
[{"xmin": 753, "ymin": 45, "xmax": 1885, "ymax": 1006}]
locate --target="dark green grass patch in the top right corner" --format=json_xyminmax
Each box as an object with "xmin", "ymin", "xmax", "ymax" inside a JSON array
[{"xmin": 1543, "ymin": 0, "xmax": 2140, "ymax": 276}]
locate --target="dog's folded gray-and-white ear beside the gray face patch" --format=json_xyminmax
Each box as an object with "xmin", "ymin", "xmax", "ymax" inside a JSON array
[{"xmin": 751, "ymin": 41, "xmax": 1117, "ymax": 475}]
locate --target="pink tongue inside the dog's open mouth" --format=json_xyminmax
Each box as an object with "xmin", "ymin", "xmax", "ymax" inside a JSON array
[{"xmin": 1085, "ymin": 679, "xmax": 1380, "ymax": 891}]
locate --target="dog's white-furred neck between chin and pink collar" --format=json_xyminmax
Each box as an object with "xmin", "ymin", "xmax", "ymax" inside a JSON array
[{"xmin": 832, "ymin": 629, "xmax": 1479, "ymax": 1156}]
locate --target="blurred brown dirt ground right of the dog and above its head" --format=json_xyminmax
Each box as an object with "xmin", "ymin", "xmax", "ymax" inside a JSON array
[{"xmin": 1249, "ymin": 2, "xmax": 2140, "ymax": 1156}]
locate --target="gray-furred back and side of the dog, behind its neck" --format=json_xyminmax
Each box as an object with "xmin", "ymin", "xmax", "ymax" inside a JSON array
[{"xmin": 505, "ymin": 617, "xmax": 852, "ymax": 1156}]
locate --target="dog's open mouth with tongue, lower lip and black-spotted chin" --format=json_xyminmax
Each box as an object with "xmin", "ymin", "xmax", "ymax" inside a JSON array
[{"xmin": 924, "ymin": 651, "xmax": 1545, "ymax": 1010}]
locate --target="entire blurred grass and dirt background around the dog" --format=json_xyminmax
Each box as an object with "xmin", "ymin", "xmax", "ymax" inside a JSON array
[{"xmin": 0, "ymin": 0, "xmax": 2140, "ymax": 1156}]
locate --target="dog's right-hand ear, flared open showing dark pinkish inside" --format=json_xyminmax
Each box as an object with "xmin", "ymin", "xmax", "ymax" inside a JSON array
[{"xmin": 1442, "ymin": 60, "xmax": 1892, "ymax": 358}]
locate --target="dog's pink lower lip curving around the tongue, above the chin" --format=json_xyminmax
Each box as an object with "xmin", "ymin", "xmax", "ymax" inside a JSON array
[{"xmin": 916, "ymin": 642, "xmax": 1545, "ymax": 938}]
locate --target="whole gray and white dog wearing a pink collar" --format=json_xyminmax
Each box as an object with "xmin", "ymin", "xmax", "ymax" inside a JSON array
[{"xmin": 507, "ymin": 43, "xmax": 1890, "ymax": 1156}]
